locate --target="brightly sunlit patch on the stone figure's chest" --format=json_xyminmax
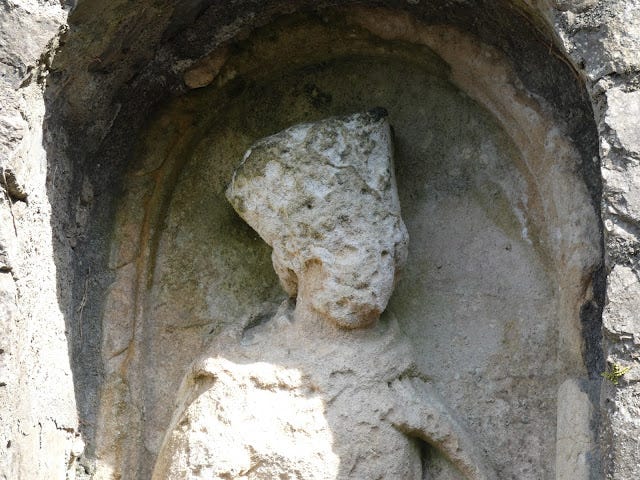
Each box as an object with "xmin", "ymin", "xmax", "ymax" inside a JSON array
[{"xmin": 153, "ymin": 359, "xmax": 339, "ymax": 479}]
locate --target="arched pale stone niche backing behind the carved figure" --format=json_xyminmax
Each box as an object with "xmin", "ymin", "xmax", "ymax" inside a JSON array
[{"xmin": 94, "ymin": 8, "xmax": 602, "ymax": 480}]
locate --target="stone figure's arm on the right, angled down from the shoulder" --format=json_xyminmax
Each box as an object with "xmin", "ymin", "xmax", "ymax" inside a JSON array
[{"xmin": 387, "ymin": 377, "xmax": 496, "ymax": 480}]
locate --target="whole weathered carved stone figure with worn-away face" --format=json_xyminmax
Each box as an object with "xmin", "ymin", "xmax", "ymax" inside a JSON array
[{"xmin": 153, "ymin": 109, "xmax": 495, "ymax": 480}]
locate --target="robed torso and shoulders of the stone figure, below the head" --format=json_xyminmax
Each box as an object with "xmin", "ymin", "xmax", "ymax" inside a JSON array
[{"xmin": 153, "ymin": 312, "xmax": 495, "ymax": 480}]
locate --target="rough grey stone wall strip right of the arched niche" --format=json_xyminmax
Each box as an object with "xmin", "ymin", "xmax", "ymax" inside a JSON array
[{"xmin": 550, "ymin": 0, "xmax": 640, "ymax": 480}]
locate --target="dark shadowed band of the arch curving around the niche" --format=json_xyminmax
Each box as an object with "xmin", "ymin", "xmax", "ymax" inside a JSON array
[{"xmin": 44, "ymin": 1, "xmax": 604, "ymax": 478}]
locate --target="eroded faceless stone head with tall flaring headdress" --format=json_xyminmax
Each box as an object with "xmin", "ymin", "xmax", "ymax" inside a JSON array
[{"xmin": 227, "ymin": 109, "xmax": 408, "ymax": 328}]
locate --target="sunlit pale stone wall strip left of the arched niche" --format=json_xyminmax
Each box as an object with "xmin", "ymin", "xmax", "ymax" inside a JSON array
[{"xmin": 0, "ymin": 0, "xmax": 84, "ymax": 480}]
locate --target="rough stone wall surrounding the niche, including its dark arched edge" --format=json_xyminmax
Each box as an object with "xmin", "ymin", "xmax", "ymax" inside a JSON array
[{"xmin": 0, "ymin": 0, "xmax": 640, "ymax": 480}]
